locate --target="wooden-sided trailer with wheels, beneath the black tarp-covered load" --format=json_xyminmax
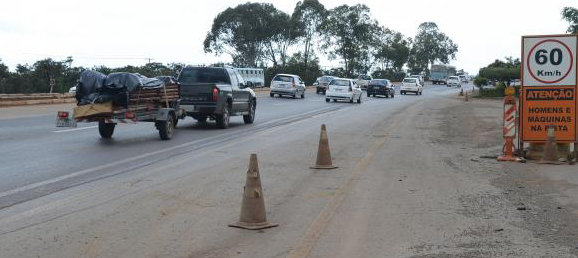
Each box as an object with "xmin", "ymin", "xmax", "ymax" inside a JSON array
[{"xmin": 56, "ymin": 84, "xmax": 185, "ymax": 140}]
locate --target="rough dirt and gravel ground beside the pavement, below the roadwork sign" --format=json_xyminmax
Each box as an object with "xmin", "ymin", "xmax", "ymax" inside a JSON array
[{"xmin": 438, "ymin": 93, "xmax": 578, "ymax": 257}]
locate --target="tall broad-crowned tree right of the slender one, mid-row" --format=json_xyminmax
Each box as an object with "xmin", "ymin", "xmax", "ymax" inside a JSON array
[{"xmin": 321, "ymin": 4, "xmax": 380, "ymax": 77}]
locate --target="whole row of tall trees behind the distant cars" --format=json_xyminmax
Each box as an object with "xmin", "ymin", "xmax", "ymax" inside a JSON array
[{"xmin": 203, "ymin": 0, "xmax": 458, "ymax": 83}]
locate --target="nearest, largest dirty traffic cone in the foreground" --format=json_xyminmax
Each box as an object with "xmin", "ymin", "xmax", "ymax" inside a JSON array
[{"xmin": 229, "ymin": 154, "xmax": 279, "ymax": 230}]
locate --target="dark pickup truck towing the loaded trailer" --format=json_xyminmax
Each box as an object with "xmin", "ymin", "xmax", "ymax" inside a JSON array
[{"xmin": 178, "ymin": 66, "xmax": 257, "ymax": 129}]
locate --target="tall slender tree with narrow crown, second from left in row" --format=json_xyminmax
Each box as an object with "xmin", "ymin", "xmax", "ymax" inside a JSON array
[{"xmin": 291, "ymin": 0, "xmax": 327, "ymax": 73}]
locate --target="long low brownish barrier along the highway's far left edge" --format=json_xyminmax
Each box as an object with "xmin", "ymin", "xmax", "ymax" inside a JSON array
[{"xmin": 0, "ymin": 93, "xmax": 76, "ymax": 107}]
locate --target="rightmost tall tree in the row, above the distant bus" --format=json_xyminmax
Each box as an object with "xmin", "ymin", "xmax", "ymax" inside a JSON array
[{"xmin": 409, "ymin": 22, "xmax": 458, "ymax": 75}]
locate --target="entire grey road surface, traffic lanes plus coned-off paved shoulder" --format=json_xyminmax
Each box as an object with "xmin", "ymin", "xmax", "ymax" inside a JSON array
[{"xmin": 0, "ymin": 85, "xmax": 576, "ymax": 258}]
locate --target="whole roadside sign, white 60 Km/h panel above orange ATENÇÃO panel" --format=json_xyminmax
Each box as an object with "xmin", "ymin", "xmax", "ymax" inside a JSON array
[{"xmin": 520, "ymin": 35, "xmax": 578, "ymax": 152}]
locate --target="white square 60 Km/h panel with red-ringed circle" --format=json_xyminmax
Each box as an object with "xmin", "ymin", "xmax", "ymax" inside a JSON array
[{"xmin": 522, "ymin": 35, "xmax": 576, "ymax": 86}]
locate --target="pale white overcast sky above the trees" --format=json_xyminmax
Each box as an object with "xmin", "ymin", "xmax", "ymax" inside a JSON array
[{"xmin": 0, "ymin": 0, "xmax": 578, "ymax": 74}]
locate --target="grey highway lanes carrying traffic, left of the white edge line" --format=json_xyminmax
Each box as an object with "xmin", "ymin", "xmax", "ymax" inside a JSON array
[{"xmin": 0, "ymin": 84, "xmax": 445, "ymax": 208}]
